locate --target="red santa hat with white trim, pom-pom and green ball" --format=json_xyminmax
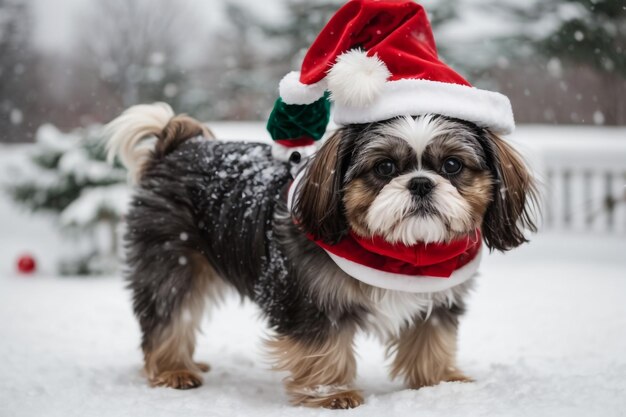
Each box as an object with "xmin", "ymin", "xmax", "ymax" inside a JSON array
[{"xmin": 268, "ymin": 0, "xmax": 515, "ymax": 159}]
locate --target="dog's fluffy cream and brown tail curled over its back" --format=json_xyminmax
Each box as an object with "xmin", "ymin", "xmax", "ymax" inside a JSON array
[{"xmin": 104, "ymin": 103, "xmax": 213, "ymax": 183}]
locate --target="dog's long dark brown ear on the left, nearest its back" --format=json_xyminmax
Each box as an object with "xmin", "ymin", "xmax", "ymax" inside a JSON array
[{"xmin": 292, "ymin": 129, "xmax": 354, "ymax": 243}]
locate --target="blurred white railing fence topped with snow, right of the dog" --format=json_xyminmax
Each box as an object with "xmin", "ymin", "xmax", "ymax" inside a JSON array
[{"xmin": 513, "ymin": 126, "xmax": 626, "ymax": 235}]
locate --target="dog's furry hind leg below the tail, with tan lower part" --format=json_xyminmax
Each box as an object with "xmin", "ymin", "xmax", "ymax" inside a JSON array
[{"xmin": 126, "ymin": 191, "xmax": 225, "ymax": 389}]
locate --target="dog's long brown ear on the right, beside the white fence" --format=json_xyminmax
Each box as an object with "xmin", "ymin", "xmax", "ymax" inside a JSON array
[{"xmin": 482, "ymin": 131, "xmax": 539, "ymax": 251}]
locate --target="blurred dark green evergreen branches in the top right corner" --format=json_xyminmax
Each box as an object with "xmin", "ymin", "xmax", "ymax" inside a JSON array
[{"xmin": 502, "ymin": 0, "xmax": 626, "ymax": 124}]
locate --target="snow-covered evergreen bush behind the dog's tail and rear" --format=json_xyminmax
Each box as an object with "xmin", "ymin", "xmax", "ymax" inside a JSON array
[{"xmin": 5, "ymin": 125, "xmax": 128, "ymax": 275}]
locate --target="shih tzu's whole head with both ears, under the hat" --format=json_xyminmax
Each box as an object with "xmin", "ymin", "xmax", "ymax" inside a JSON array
[{"xmin": 294, "ymin": 115, "xmax": 535, "ymax": 250}]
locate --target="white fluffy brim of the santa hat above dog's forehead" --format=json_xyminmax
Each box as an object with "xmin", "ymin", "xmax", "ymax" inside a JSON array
[{"xmin": 333, "ymin": 79, "xmax": 515, "ymax": 134}]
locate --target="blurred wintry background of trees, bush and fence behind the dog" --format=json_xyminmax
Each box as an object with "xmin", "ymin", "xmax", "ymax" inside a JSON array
[{"xmin": 0, "ymin": 0, "xmax": 626, "ymax": 275}]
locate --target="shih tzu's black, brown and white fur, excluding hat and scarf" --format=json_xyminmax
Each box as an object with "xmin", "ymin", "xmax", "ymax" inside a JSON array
[{"xmin": 109, "ymin": 105, "xmax": 535, "ymax": 408}]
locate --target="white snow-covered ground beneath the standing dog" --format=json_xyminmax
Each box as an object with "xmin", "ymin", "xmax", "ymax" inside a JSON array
[{"xmin": 0, "ymin": 134, "xmax": 626, "ymax": 417}]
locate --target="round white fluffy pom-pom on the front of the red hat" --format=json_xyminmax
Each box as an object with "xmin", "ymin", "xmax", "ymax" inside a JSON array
[{"xmin": 326, "ymin": 49, "xmax": 391, "ymax": 107}]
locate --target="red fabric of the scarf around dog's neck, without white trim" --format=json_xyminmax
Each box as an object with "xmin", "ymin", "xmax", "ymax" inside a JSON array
[{"xmin": 309, "ymin": 230, "xmax": 482, "ymax": 278}]
